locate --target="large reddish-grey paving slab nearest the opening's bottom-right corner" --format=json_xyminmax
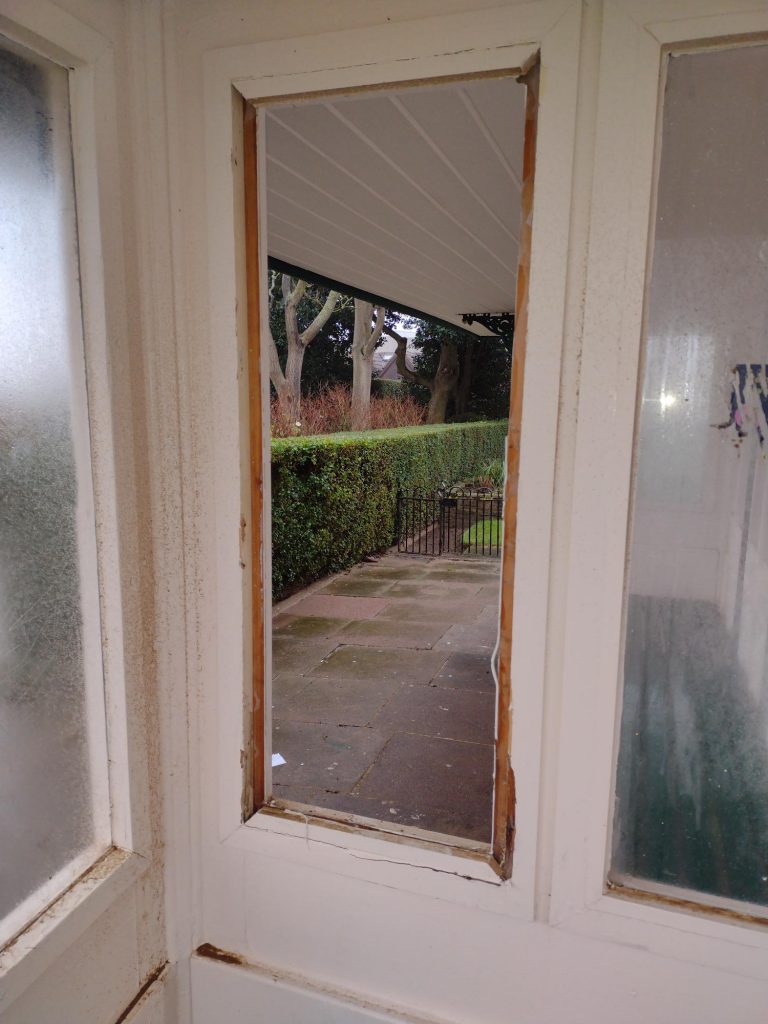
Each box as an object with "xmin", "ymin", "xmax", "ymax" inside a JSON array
[{"xmin": 353, "ymin": 732, "xmax": 494, "ymax": 827}]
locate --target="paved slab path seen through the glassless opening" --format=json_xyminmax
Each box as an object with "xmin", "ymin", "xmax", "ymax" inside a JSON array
[{"xmin": 272, "ymin": 555, "xmax": 501, "ymax": 842}]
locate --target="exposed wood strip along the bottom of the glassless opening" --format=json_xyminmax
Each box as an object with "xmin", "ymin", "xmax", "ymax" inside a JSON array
[{"xmin": 259, "ymin": 800, "xmax": 493, "ymax": 863}]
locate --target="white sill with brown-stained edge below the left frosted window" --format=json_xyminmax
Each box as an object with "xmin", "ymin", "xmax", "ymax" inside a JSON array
[{"xmin": 0, "ymin": 847, "xmax": 146, "ymax": 1016}]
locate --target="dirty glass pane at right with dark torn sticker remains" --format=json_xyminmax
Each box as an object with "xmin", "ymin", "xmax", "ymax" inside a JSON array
[{"xmin": 612, "ymin": 46, "xmax": 768, "ymax": 904}]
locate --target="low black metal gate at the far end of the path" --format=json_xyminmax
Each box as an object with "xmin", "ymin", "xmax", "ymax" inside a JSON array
[{"xmin": 397, "ymin": 486, "xmax": 504, "ymax": 558}]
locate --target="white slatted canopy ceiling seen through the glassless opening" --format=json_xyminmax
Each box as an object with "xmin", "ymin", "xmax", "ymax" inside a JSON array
[{"xmin": 266, "ymin": 78, "xmax": 524, "ymax": 334}]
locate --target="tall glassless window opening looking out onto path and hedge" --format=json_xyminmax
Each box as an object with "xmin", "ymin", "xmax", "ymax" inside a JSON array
[{"xmin": 244, "ymin": 59, "xmax": 538, "ymax": 873}]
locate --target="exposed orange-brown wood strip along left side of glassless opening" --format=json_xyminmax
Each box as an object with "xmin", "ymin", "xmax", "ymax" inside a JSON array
[{"xmin": 243, "ymin": 102, "xmax": 266, "ymax": 817}]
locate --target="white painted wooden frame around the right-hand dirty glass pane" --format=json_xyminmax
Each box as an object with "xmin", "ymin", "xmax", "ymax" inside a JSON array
[{"xmin": 548, "ymin": 0, "xmax": 768, "ymax": 978}]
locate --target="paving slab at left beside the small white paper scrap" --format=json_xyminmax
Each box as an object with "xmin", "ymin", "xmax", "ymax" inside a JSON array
[{"xmin": 272, "ymin": 719, "xmax": 387, "ymax": 791}]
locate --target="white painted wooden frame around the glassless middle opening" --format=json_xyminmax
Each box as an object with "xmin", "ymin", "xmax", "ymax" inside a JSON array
[{"xmin": 198, "ymin": 0, "xmax": 580, "ymax": 915}]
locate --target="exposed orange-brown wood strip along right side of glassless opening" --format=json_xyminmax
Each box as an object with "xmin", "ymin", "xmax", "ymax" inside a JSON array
[{"xmin": 492, "ymin": 56, "xmax": 540, "ymax": 879}]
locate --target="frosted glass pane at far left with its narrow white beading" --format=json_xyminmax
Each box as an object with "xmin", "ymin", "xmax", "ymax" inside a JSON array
[{"xmin": 0, "ymin": 37, "xmax": 111, "ymax": 934}]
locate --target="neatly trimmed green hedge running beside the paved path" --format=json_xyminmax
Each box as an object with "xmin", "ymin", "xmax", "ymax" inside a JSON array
[{"xmin": 271, "ymin": 420, "xmax": 507, "ymax": 598}]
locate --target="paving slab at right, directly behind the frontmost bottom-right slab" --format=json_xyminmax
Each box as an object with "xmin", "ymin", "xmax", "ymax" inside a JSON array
[{"xmin": 370, "ymin": 683, "xmax": 496, "ymax": 743}]
